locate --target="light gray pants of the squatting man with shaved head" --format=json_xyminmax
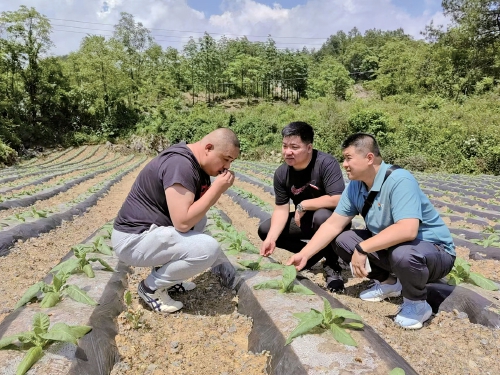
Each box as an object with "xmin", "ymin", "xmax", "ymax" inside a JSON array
[{"xmin": 111, "ymin": 217, "xmax": 220, "ymax": 289}]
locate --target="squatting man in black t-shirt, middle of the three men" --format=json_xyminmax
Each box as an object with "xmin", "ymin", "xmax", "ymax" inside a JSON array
[{"xmin": 258, "ymin": 122, "xmax": 345, "ymax": 291}]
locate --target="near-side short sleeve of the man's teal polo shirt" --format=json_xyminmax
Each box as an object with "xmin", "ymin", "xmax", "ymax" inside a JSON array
[{"xmin": 390, "ymin": 177, "xmax": 422, "ymax": 223}]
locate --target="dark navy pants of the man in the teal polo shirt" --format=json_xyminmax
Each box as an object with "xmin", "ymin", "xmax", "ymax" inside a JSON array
[{"xmin": 335, "ymin": 229, "xmax": 455, "ymax": 301}]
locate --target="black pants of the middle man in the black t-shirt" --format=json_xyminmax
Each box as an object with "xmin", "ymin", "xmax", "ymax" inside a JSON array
[{"xmin": 258, "ymin": 208, "xmax": 351, "ymax": 271}]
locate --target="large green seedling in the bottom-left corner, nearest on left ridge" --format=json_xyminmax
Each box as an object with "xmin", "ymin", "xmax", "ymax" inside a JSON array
[{"xmin": 0, "ymin": 312, "xmax": 92, "ymax": 375}]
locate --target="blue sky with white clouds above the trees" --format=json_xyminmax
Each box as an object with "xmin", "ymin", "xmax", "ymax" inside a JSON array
[{"xmin": 0, "ymin": 0, "xmax": 447, "ymax": 55}]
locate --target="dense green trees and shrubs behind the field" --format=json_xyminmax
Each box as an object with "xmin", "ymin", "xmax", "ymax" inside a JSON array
[{"xmin": 0, "ymin": 0, "xmax": 500, "ymax": 174}]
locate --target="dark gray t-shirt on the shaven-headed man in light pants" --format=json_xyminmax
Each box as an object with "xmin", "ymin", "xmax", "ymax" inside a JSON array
[{"xmin": 114, "ymin": 143, "xmax": 210, "ymax": 234}]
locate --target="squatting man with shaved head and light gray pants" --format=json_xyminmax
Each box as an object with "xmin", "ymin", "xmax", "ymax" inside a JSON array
[{"xmin": 111, "ymin": 128, "xmax": 240, "ymax": 313}]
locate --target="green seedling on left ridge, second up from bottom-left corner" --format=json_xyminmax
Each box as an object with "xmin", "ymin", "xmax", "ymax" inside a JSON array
[{"xmin": 14, "ymin": 272, "xmax": 97, "ymax": 309}]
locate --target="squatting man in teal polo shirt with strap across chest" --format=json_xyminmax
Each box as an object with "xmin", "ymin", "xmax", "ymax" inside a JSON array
[{"xmin": 288, "ymin": 133, "xmax": 455, "ymax": 329}]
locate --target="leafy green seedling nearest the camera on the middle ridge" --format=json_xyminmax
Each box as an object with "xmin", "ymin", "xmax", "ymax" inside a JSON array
[{"xmin": 285, "ymin": 297, "xmax": 363, "ymax": 346}]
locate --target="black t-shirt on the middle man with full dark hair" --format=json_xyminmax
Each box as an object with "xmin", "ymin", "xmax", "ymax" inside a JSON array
[{"xmin": 274, "ymin": 150, "xmax": 345, "ymax": 206}]
